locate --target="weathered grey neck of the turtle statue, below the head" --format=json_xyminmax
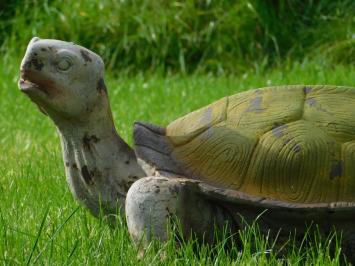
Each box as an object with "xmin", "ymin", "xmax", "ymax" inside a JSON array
[{"xmin": 55, "ymin": 109, "xmax": 145, "ymax": 216}]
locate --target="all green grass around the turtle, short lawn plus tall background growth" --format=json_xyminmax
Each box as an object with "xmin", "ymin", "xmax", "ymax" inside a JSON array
[{"xmin": 0, "ymin": 0, "xmax": 355, "ymax": 265}]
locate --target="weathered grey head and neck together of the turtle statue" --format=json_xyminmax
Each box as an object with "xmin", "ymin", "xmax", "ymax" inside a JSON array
[{"xmin": 19, "ymin": 39, "xmax": 145, "ymax": 218}]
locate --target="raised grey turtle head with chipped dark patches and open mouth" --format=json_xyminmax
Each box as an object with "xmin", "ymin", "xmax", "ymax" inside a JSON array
[{"xmin": 19, "ymin": 37, "xmax": 108, "ymax": 121}]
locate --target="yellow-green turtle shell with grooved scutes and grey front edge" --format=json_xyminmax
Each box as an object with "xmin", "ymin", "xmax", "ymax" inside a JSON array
[{"xmin": 134, "ymin": 86, "xmax": 355, "ymax": 203}]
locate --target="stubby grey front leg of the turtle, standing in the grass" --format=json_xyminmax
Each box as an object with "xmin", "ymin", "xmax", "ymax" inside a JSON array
[{"xmin": 126, "ymin": 177, "xmax": 237, "ymax": 245}]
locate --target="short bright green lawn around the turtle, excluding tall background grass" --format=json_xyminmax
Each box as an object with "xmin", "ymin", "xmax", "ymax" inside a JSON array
[{"xmin": 0, "ymin": 56, "xmax": 355, "ymax": 265}]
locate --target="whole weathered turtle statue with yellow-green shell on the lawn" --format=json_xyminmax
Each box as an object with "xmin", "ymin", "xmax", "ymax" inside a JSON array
[{"xmin": 19, "ymin": 37, "xmax": 355, "ymax": 260}]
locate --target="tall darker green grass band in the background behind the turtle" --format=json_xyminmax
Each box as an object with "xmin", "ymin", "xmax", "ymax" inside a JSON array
[{"xmin": 0, "ymin": 0, "xmax": 355, "ymax": 73}]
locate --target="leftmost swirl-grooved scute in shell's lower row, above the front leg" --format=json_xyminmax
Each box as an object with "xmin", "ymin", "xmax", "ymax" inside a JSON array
[{"xmin": 171, "ymin": 123, "xmax": 257, "ymax": 187}]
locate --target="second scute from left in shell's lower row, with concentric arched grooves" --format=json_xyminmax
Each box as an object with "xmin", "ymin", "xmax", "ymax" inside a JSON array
[{"xmin": 242, "ymin": 120, "xmax": 341, "ymax": 202}]
